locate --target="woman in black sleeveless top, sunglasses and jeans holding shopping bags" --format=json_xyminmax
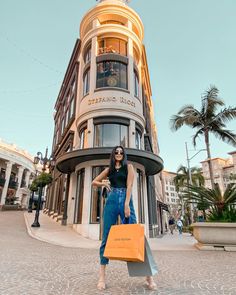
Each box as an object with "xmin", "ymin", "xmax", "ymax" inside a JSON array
[{"xmin": 92, "ymin": 146, "xmax": 157, "ymax": 290}]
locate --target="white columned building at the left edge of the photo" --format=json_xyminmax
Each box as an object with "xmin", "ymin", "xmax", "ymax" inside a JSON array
[{"xmin": 0, "ymin": 140, "xmax": 35, "ymax": 208}]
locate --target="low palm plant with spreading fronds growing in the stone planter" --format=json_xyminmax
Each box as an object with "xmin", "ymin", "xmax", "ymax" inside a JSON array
[{"xmin": 185, "ymin": 183, "xmax": 236, "ymax": 221}]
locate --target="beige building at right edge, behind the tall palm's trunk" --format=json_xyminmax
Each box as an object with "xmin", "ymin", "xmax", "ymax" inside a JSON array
[{"xmin": 201, "ymin": 151, "xmax": 236, "ymax": 192}]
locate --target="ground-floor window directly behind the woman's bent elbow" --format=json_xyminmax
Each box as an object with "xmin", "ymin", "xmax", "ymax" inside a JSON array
[{"xmin": 90, "ymin": 166, "xmax": 106, "ymax": 223}]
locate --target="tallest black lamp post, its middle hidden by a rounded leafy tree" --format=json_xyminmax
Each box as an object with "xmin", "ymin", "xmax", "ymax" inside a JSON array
[{"xmin": 31, "ymin": 148, "xmax": 49, "ymax": 227}]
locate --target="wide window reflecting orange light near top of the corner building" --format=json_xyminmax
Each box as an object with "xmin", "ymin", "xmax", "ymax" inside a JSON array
[{"xmin": 98, "ymin": 38, "xmax": 127, "ymax": 56}]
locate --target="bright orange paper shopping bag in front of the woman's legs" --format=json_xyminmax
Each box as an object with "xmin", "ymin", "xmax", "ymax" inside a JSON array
[{"xmin": 104, "ymin": 224, "xmax": 144, "ymax": 262}]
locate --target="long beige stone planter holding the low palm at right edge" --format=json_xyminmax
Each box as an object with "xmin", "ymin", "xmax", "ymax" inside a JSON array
[{"xmin": 193, "ymin": 222, "xmax": 236, "ymax": 251}]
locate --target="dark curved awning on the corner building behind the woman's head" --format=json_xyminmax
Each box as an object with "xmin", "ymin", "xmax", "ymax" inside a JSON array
[{"xmin": 56, "ymin": 147, "xmax": 163, "ymax": 175}]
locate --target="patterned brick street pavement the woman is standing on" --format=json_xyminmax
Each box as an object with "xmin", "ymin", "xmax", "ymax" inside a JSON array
[{"xmin": 0, "ymin": 211, "xmax": 236, "ymax": 295}]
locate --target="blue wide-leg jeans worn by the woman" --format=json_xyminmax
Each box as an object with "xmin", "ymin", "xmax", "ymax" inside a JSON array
[{"xmin": 100, "ymin": 187, "xmax": 137, "ymax": 265}]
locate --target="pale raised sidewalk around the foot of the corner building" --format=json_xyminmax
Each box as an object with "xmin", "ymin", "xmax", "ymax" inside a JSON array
[{"xmin": 24, "ymin": 212, "xmax": 198, "ymax": 251}]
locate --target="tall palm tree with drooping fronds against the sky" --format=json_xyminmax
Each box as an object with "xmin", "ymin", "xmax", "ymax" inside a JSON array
[{"xmin": 170, "ymin": 86, "xmax": 236, "ymax": 188}]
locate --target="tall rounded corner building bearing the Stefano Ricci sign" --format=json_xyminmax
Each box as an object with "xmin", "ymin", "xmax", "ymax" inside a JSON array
[{"xmin": 46, "ymin": 0, "xmax": 163, "ymax": 239}]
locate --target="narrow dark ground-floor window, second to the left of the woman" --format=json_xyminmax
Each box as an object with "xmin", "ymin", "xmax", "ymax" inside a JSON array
[{"xmin": 74, "ymin": 169, "xmax": 85, "ymax": 224}]
